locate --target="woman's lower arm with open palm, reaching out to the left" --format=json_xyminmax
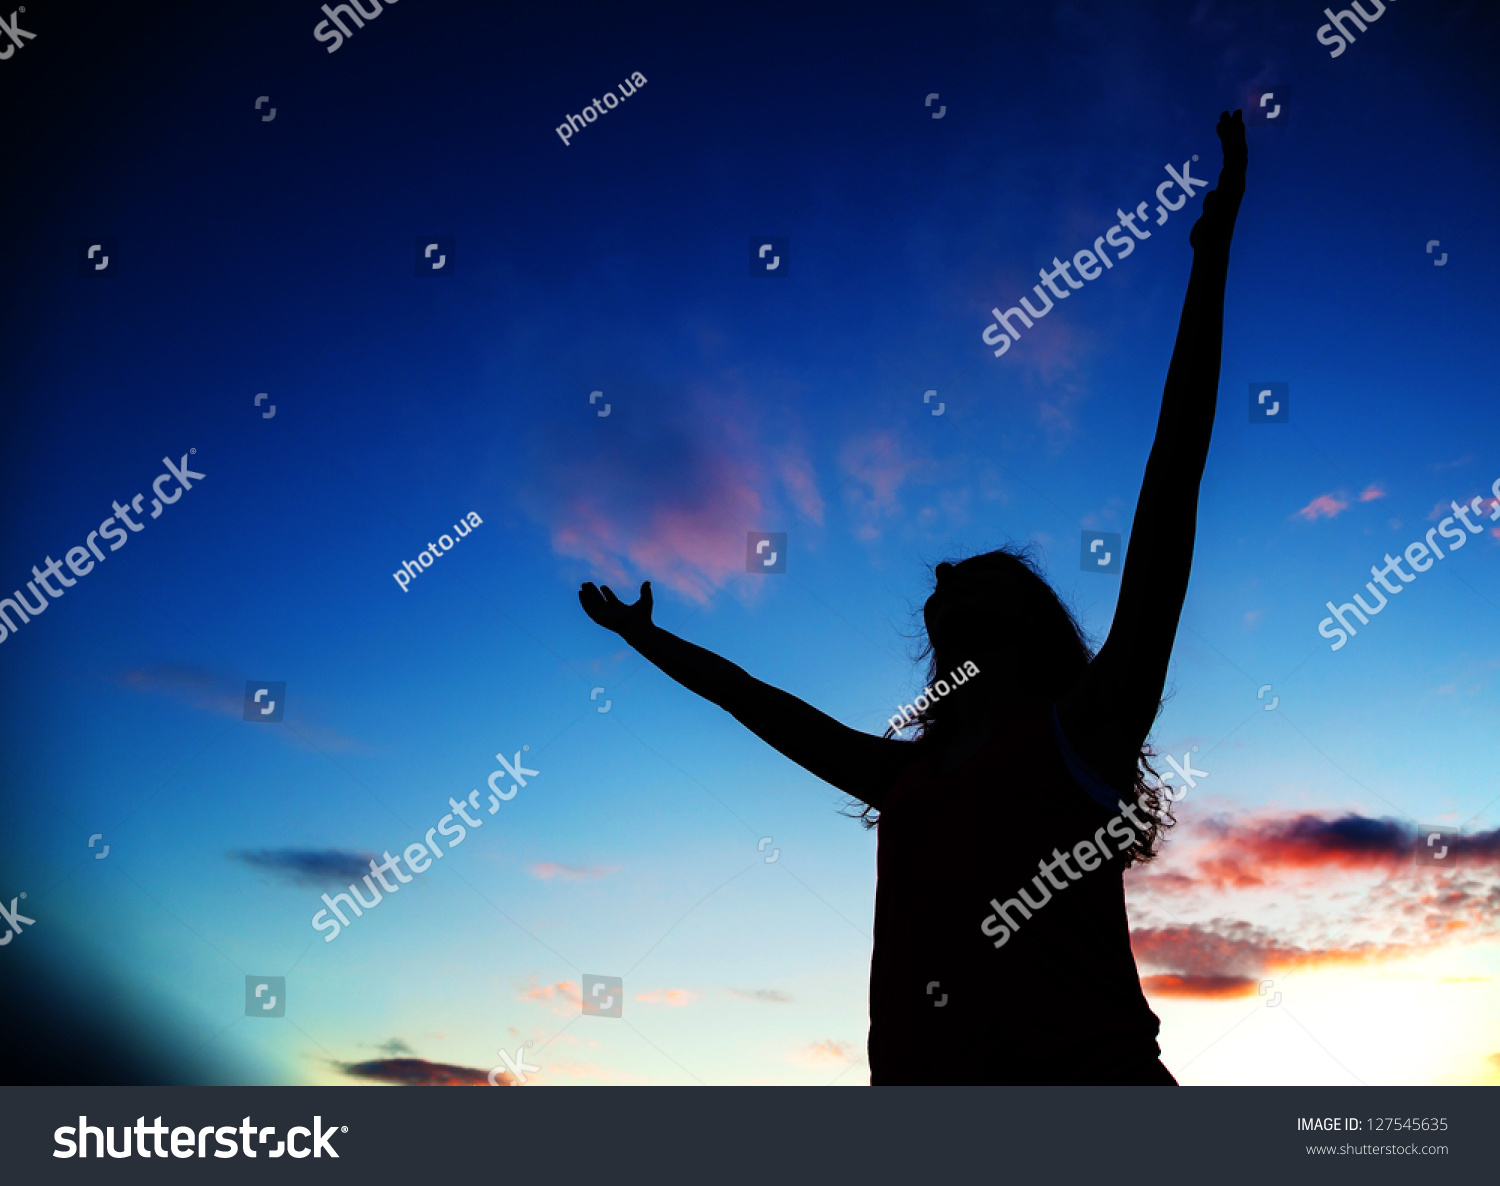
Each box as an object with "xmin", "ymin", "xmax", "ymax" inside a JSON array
[{"xmin": 578, "ymin": 582, "xmax": 914, "ymax": 808}]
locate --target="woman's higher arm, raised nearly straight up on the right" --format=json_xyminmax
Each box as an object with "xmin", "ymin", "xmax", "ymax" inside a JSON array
[{"xmin": 1058, "ymin": 111, "xmax": 1248, "ymax": 786}]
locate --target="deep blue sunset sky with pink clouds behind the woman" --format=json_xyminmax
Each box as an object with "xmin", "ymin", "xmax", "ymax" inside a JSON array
[{"xmin": 0, "ymin": 3, "xmax": 1500, "ymax": 1084}]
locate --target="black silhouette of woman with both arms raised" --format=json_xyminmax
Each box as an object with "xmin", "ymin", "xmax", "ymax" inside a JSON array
[{"xmin": 579, "ymin": 111, "xmax": 1248, "ymax": 1086}]
